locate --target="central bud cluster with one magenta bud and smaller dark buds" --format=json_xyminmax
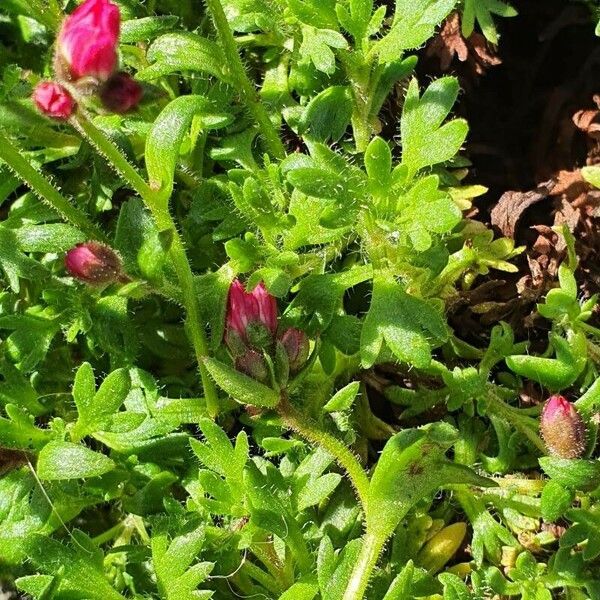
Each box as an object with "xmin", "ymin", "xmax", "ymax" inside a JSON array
[{"xmin": 224, "ymin": 279, "xmax": 309, "ymax": 385}]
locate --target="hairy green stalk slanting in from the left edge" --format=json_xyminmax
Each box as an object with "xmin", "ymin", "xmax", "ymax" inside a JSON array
[{"xmin": 0, "ymin": 133, "xmax": 105, "ymax": 240}]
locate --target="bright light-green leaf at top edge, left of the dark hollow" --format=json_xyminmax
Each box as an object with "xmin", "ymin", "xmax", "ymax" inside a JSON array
[{"xmin": 375, "ymin": 0, "xmax": 456, "ymax": 62}]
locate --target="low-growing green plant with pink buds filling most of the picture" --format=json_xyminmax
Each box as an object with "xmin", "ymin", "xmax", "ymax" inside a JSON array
[{"xmin": 0, "ymin": 0, "xmax": 600, "ymax": 600}]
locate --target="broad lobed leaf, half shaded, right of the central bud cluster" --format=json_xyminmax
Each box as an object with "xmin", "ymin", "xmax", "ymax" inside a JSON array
[{"xmin": 360, "ymin": 274, "xmax": 448, "ymax": 368}]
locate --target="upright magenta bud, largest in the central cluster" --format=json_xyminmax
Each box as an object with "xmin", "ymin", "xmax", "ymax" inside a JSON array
[{"xmin": 225, "ymin": 279, "xmax": 277, "ymax": 354}]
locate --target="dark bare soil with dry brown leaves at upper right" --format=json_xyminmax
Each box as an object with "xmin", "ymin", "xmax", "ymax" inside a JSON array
[{"xmin": 418, "ymin": 0, "xmax": 600, "ymax": 344}]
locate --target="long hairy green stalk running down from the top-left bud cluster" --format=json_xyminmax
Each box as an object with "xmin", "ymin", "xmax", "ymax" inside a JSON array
[{"xmin": 71, "ymin": 114, "xmax": 219, "ymax": 417}]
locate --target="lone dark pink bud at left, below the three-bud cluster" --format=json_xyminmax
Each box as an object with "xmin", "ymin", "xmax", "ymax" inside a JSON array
[{"xmin": 65, "ymin": 242, "xmax": 126, "ymax": 284}]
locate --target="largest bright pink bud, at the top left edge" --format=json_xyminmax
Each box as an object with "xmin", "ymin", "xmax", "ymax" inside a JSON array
[{"xmin": 58, "ymin": 0, "xmax": 121, "ymax": 81}]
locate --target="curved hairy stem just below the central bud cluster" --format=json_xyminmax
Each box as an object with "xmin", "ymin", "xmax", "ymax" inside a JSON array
[{"xmin": 278, "ymin": 398, "xmax": 369, "ymax": 512}]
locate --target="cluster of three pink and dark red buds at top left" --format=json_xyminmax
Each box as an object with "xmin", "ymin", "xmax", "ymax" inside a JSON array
[{"xmin": 32, "ymin": 0, "xmax": 143, "ymax": 120}]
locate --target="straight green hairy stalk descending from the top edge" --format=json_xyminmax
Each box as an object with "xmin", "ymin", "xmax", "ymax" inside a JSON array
[{"xmin": 206, "ymin": 0, "xmax": 285, "ymax": 159}]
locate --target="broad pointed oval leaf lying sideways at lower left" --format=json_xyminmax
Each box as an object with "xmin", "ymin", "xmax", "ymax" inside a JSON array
[{"xmin": 37, "ymin": 441, "xmax": 115, "ymax": 480}]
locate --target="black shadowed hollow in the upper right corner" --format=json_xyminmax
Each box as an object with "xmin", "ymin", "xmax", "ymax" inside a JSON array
[{"xmin": 419, "ymin": 0, "xmax": 600, "ymax": 200}]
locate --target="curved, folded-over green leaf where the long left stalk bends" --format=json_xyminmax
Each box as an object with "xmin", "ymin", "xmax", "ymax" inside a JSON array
[{"xmin": 145, "ymin": 96, "xmax": 208, "ymax": 201}]
